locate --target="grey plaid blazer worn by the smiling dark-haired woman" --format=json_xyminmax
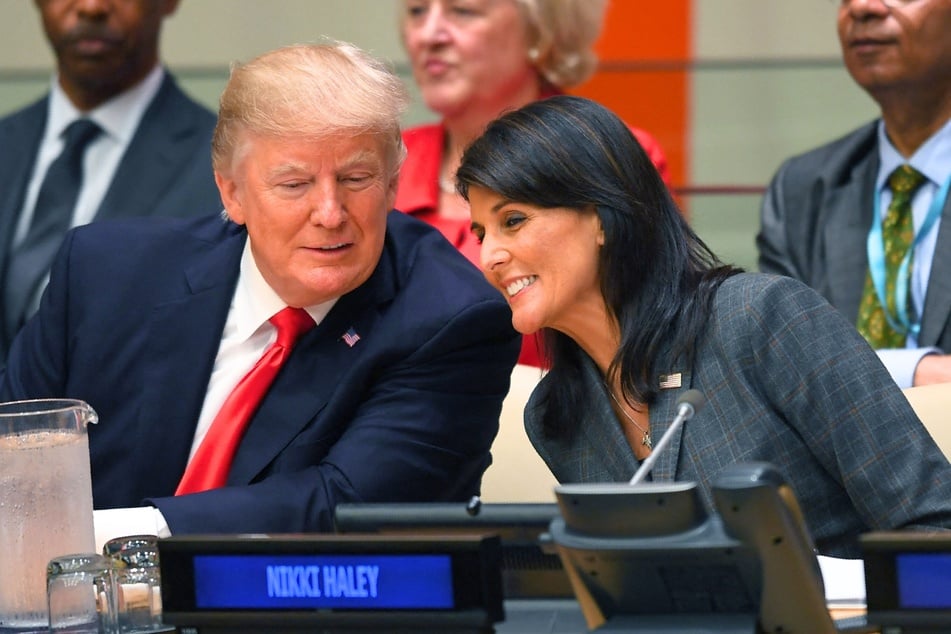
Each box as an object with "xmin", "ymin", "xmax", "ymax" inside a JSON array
[{"xmin": 525, "ymin": 274, "xmax": 951, "ymax": 556}]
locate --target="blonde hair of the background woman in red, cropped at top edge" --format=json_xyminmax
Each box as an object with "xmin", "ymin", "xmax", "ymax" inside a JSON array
[{"xmin": 516, "ymin": 0, "xmax": 607, "ymax": 88}]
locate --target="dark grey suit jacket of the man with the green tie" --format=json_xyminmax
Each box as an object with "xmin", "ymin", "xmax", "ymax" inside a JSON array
[{"xmin": 756, "ymin": 121, "xmax": 951, "ymax": 352}]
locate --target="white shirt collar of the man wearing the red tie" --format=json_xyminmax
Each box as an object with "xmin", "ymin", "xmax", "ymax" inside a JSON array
[{"xmin": 232, "ymin": 239, "xmax": 339, "ymax": 341}]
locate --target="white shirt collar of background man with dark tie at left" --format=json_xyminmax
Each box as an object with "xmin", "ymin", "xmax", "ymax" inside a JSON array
[{"xmin": 44, "ymin": 65, "xmax": 165, "ymax": 144}]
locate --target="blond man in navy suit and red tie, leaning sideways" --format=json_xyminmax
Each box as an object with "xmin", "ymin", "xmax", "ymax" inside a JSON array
[{"xmin": 0, "ymin": 43, "xmax": 519, "ymax": 541}]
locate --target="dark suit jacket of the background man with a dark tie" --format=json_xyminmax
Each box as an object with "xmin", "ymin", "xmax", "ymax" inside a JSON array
[{"xmin": 0, "ymin": 73, "xmax": 221, "ymax": 358}]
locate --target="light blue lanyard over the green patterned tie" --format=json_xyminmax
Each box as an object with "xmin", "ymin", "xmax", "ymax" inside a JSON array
[{"xmin": 868, "ymin": 176, "xmax": 951, "ymax": 337}]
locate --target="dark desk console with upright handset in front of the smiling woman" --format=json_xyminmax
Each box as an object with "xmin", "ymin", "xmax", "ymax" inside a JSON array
[{"xmin": 551, "ymin": 463, "xmax": 836, "ymax": 634}]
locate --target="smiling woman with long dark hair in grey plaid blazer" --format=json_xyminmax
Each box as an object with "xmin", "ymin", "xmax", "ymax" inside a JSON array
[{"xmin": 457, "ymin": 96, "xmax": 951, "ymax": 556}]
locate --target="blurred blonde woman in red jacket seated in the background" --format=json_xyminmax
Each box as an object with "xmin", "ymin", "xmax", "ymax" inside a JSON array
[{"xmin": 396, "ymin": 0, "xmax": 669, "ymax": 366}]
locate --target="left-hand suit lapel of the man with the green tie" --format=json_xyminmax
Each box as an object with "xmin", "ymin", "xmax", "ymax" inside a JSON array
[{"xmin": 819, "ymin": 152, "xmax": 878, "ymax": 323}]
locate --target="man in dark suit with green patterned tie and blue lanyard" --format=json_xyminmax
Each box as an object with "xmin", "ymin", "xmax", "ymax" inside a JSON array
[{"xmin": 757, "ymin": 0, "xmax": 951, "ymax": 388}]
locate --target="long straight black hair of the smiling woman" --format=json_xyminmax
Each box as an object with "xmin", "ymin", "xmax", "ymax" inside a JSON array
[{"xmin": 456, "ymin": 95, "xmax": 740, "ymax": 434}]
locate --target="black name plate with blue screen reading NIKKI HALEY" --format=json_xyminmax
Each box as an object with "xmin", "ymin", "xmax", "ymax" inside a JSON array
[{"xmin": 159, "ymin": 534, "xmax": 504, "ymax": 631}]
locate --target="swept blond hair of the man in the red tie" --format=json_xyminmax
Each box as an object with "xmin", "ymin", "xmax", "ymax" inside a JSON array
[{"xmin": 211, "ymin": 42, "xmax": 409, "ymax": 174}]
